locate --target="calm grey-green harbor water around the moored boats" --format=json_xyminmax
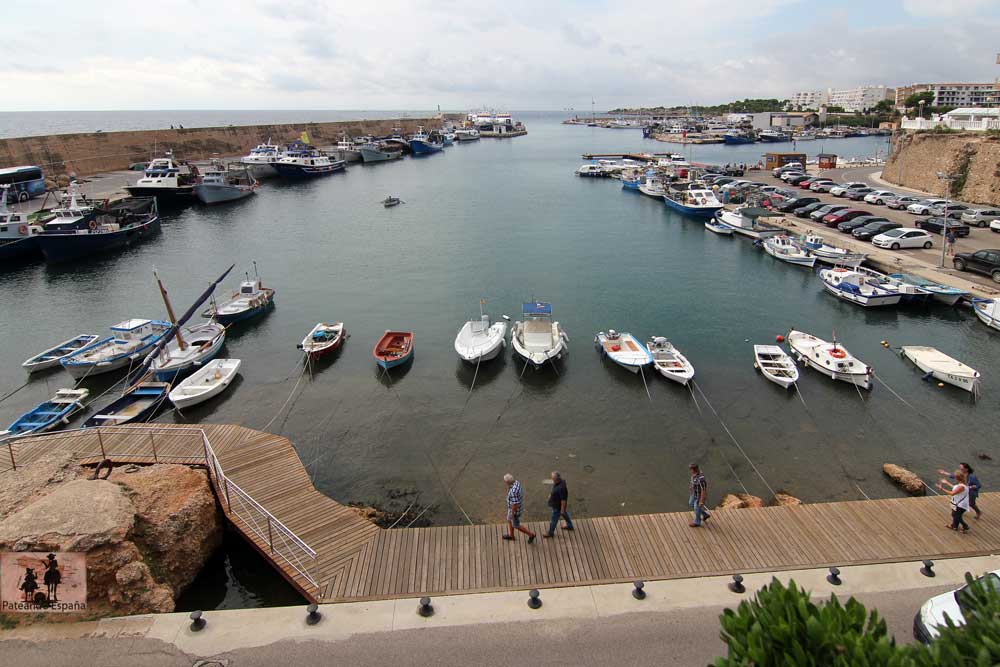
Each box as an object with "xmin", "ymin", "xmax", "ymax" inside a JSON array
[{"xmin": 0, "ymin": 113, "xmax": 1000, "ymax": 606}]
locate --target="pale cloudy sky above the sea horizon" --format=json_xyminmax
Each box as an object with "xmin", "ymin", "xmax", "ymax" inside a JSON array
[{"xmin": 7, "ymin": 0, "xmax": 1000, "ymax": 111}]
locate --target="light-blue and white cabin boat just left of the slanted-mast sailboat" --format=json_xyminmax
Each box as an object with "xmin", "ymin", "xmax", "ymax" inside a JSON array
[{"xmin": 59, "ymin": 319, "xmax": 172, "ymax": 380}]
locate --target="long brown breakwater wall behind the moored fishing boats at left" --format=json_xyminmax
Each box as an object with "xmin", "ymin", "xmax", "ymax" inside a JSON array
[{"xmin": 0, "ymin": 117, "xmax": 442, "ymax": 177}]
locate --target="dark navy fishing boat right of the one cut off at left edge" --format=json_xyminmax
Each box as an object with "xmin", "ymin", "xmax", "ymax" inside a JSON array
[{"xmin": 37, "ymin": 197, "xmax": 160, "ymax": 262}]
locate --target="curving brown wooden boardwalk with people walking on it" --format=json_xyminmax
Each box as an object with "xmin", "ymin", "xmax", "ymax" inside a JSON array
[{"xmin": 0, "ymin": 425, "xmax": 1000, "ymax": 602}]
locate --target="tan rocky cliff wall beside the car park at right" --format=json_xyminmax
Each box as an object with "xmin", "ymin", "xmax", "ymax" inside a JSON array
[{"xmin": 882, "ymin": 132, "xmax": 1000, "ymax": 205}]
